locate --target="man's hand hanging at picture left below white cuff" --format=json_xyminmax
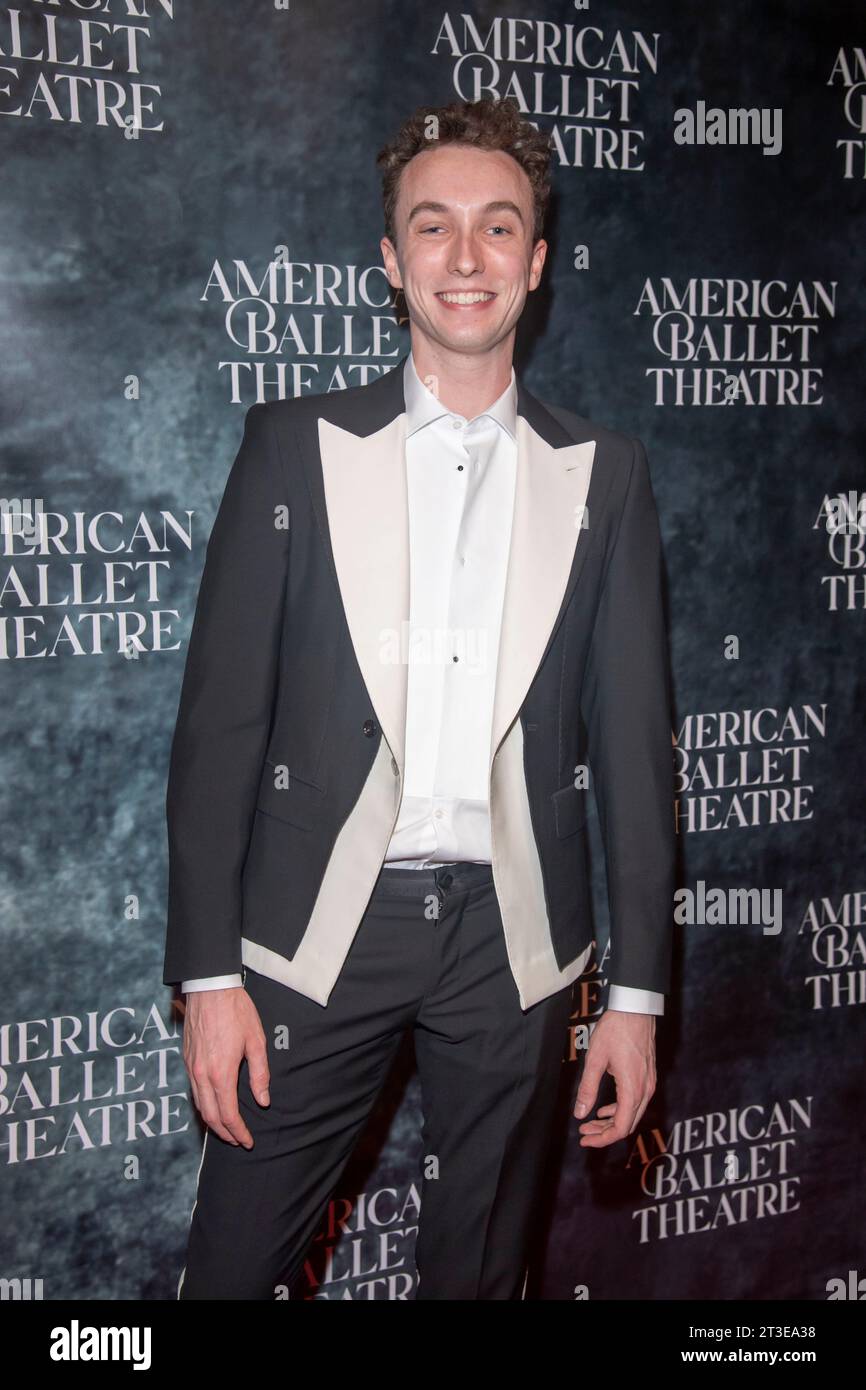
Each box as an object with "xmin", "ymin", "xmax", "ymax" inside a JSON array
[{"xmin": 183, "ymin": 988, "xmax": 271, "ymax": 1148}]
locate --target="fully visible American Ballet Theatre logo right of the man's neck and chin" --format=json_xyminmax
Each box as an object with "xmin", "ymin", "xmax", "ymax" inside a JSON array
[{"xmin": 634, "ymin": 275, "xmax": 837, "ymax": 406}]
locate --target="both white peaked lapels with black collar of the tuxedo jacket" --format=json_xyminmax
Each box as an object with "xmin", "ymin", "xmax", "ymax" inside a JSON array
[{"xmin": 302, "ymin": 357, "xmax": 607, "ymax": 776}]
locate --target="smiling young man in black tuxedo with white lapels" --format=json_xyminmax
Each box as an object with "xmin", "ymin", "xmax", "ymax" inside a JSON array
[{"xmin": 164, "ymin": 101, "xmax": 674, "ymax": 1300}]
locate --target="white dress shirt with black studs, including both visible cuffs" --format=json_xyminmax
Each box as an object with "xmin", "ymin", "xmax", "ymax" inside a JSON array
[{"xmin": 182, "ymin": 353, "xmax": 664, "ymax": 1013}]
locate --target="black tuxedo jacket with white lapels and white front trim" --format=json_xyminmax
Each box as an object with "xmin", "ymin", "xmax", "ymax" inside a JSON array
[{"xmin": 164, "ymin": 359, "xmax": 676, "ymax": 1009}]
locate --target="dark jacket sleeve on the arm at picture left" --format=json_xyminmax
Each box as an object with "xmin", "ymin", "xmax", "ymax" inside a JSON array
[{"xmin": 163, "ymin": 403, "xmax": 289, "ymax": 984}]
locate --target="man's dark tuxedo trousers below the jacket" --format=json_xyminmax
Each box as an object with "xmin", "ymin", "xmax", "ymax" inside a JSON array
[{"xmin": 178, "ymin": 863, "xmax": 571, "ymax": 1300}]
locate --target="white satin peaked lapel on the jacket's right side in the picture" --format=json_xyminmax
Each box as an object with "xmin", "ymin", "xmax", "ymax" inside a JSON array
[{"xmin": 491, "ymin": 416, "xmax": 595, "ymax": 762}]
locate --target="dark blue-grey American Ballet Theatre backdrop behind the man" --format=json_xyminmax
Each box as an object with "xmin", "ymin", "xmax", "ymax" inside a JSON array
[{"xmin": 0, "ymin": 0, "xmax": 866, "ymax": 1301}]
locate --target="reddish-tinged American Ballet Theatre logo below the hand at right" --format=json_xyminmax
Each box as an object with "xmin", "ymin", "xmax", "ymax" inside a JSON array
[{"xmin": 626, "ymin": 1095, "xmax": 813, "ymax": 1245}]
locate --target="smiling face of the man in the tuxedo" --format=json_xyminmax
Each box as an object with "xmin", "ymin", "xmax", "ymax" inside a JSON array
[{"xmin": 381, "ymin": 142, "xmax": 548, "ymax": 354}]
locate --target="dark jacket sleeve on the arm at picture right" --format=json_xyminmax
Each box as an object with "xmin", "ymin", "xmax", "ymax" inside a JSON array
[{"xmin": 581, "ymin": 439, "xmax": 676, "ymax": 1012}]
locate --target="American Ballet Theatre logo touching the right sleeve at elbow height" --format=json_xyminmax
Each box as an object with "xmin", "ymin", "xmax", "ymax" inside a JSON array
[{"xmin": 674, "ymin": 703, "xmax": 827, "ymax": 834}]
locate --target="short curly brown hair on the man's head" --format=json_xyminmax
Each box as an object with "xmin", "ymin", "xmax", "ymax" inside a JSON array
[{"xmin": 375, "ymin": 97, "xmax": 550, "ymax": 246}]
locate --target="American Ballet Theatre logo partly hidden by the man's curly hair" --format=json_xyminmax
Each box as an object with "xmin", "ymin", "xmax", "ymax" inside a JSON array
[{"xmin": 430, "ymin": 10, "xmax": 660, "ymax": 172}]
